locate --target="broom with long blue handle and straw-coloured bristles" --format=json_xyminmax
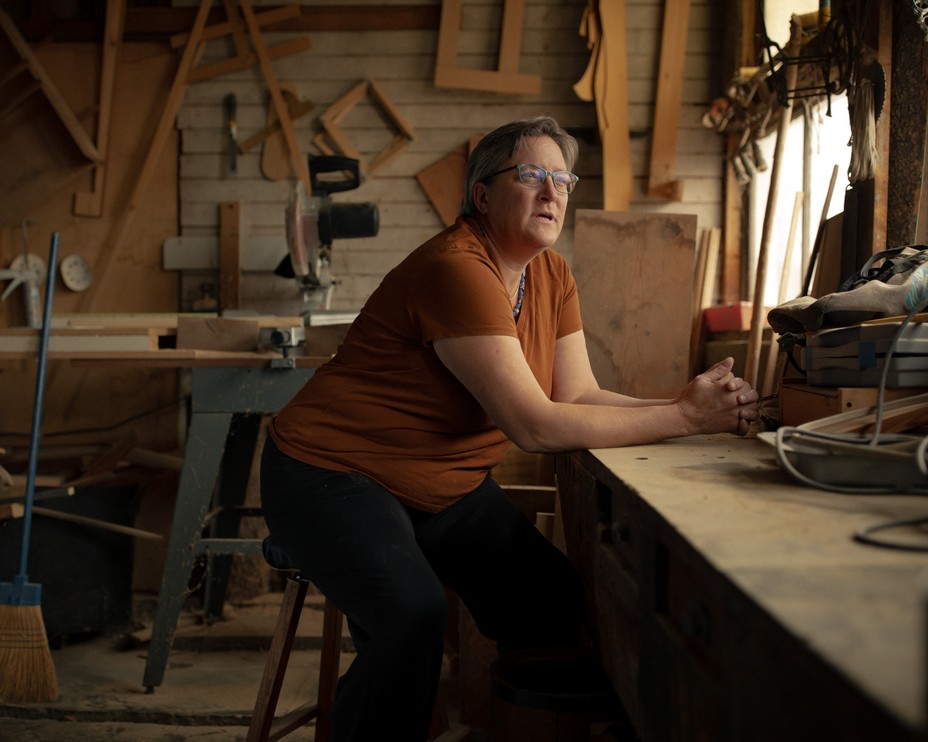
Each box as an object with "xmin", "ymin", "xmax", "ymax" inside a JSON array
[{"xmin": 0, "ymin": 232, "xmax": 58, "ymax": 703}]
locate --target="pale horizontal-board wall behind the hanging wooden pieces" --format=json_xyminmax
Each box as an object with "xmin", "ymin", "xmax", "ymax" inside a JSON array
[{"xmin": 176, "ymin": 0, "xmax": 725, "ymax": 315}]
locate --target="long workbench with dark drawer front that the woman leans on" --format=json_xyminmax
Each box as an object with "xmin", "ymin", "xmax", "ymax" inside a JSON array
[{"xmin": 557, "ymin": 435, "xmax": 928, "ymax": 742}]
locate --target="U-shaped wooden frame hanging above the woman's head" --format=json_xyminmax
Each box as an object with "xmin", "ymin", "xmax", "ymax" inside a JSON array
[{"xmin": 435, "ymin": 0, "xmax": 541, "ymax": 95}]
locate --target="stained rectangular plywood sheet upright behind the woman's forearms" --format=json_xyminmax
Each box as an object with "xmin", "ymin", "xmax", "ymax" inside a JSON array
[{"xmin": 573, "ymin": 209, "xmax": 696, "ymax": 397}]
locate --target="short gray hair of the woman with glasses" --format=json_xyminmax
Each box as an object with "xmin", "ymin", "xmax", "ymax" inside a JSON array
[{"xmin": 461, "ymin": 116, "xmax": 579, "ymax": 216}]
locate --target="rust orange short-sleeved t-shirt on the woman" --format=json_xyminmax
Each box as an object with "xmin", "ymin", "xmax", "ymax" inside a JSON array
[{"xmin": 269, "ymin": 218, "xmax": 581, "ymax": 512}]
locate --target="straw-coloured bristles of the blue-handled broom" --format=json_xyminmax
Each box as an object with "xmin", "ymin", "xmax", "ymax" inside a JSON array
[{"xmin": 0, "ymin": 605, "xmax": 58, "ymax": 703}]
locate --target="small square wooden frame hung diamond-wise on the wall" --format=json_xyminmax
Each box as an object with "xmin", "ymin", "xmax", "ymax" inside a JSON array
[{"xmin": 313, "ymin": 80, "xmax": 416, "ymax": 177}]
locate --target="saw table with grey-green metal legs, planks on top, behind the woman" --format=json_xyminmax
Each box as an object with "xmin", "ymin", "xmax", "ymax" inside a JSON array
[{"xmin": 0, "ymin": 326, "xmax": 330, "ymax": 691}]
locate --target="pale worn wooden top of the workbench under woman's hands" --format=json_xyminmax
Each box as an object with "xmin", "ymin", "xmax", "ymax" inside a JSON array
[{"xmin": 581, "ymin": 435, "xmax": 928, "ymax": 729}]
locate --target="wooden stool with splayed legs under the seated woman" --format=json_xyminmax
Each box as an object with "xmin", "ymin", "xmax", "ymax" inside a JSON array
[{"xmin": 247, "ymin": 576, "xmax": 470, "ymax": 742}]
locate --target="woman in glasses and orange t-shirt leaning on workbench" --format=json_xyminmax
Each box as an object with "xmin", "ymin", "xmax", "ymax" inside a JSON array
[{"xmin": 261, "ymin": 117, "xmax": 757, "ymax": 742}]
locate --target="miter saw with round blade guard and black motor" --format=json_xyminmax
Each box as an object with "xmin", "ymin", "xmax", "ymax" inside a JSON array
[{"xmin": 274, "ymin": 155, "xmax": 380, "ymax": 314}]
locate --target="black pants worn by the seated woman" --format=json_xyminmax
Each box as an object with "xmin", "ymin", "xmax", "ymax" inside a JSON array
[{"xmin": 261, "ymin": 439, "xmax": 582, "ymax": 742}]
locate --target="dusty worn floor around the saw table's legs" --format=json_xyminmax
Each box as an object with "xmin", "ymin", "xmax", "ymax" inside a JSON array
[{"xmin": 0, "ymin": 594, "xmax": 353, "ymax": 742}]
